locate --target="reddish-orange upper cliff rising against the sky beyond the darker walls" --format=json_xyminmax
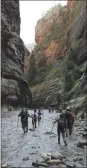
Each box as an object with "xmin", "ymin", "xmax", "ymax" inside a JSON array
[{"xmin": 35, "ymin": 0, "xmax": 76, "ymax": 59}]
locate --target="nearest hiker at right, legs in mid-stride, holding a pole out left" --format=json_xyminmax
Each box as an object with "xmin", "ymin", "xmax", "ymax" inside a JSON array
[{"xmin": 54, "ymin": 114, "xmax": 67, "ymax": 146}]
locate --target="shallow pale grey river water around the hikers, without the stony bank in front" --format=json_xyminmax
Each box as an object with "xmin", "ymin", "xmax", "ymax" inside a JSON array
[{"xmin": 1, "ymin": 110, "xmax": 85, "ymax": 168}]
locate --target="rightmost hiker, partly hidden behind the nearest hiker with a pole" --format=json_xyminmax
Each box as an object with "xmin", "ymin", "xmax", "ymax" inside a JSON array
[{"xmin": 65, "ymin": 107, "xmax": 73, "ymax": 136}]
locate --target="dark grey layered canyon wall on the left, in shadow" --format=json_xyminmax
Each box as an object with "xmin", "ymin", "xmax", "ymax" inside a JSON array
[{"xmin": 1, "ymin": 0, "xmax": 31, "ymax": 105}]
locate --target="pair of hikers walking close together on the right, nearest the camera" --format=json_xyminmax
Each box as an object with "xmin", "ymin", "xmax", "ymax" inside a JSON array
[{"xmin": 53, "ymin": 107, "xmax": 75, "ymax": 146}]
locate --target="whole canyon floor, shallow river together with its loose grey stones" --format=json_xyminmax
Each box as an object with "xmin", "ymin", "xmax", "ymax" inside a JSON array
[{"xmin": 1, "ymin": 110, "xmax": 87, "ymax": 168}]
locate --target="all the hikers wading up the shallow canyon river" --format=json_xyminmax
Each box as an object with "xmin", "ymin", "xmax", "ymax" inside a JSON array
[{"xmin": 18, "ymin": 107, "xmax": 75, "ymax": 146}]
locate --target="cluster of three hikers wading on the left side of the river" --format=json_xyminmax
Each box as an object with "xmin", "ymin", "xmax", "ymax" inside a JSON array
[{"xmin": 18, "ymin": 108, "xmax": 42, "ymax": 133}]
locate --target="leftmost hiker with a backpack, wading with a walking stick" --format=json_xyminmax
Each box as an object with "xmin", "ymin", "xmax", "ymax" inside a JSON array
[{"xmin": 18, "ymin": 108, "xmax": 30, "ymax": 133}]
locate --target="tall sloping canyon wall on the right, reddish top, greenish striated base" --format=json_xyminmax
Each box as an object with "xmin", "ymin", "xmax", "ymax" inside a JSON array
[{"xmin": 31, "ymin": 1, "xmax": 87, "ymax": 105}]
